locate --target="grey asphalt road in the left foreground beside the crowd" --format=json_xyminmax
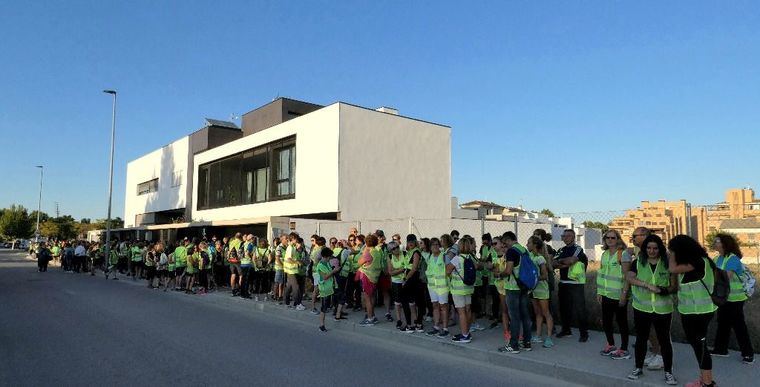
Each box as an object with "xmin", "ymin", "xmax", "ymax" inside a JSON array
[{"xmin": 0, "ymin": 250, "xmax": 580, "ymax": 386}]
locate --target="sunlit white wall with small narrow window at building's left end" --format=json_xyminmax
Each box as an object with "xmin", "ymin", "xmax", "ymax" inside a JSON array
[{"xmin": 124, "ymin": 137, "xmax": 190, "ymax": 227}]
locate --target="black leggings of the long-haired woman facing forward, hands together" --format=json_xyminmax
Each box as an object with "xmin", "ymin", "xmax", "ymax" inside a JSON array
[{"xmin": 633, "ymin": 309, "xmax": 673, "ymax": 372}]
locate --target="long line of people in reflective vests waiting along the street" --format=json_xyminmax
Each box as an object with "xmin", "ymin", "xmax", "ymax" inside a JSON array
[{"xmin": 31, "ymin": 227, "xmax": 754, "ymax": 386}]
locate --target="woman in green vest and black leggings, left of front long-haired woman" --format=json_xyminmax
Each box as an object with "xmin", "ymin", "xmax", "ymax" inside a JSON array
[{"xmin": 596, "ymin": 230, "xmax": 631, "ymax": 360}]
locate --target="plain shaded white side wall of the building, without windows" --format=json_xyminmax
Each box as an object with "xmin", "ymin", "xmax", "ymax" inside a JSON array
[{"xmin": 338, "ymin": 103, "xmax": 451, "ymax": 220}]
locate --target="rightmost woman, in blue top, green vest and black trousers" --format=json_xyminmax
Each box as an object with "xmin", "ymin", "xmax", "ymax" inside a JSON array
[{"xmin": 711, "ymin": 233, "xmax": 755, "ymax": 364}]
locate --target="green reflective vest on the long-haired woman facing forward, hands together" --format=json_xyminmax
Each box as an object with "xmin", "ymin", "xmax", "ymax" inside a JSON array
[{"xmin": 631, "ymin": 258, "xmax": 673, "ymax": 314}]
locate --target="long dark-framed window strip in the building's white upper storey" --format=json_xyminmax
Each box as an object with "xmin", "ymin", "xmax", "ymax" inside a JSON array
[{"xmin": 197, "ymin": 137, "xmax": 296, "ymax": 210}]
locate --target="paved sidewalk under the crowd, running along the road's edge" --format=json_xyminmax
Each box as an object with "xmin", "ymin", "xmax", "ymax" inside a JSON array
[{"xmin": 35, "ymin": 256, "xmax": 760, "ymax": 387}]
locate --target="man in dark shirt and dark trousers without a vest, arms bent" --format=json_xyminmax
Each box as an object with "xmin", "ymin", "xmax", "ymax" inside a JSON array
[{"xmin": 554, "ymin": 229, "xmax": 588, "ymax": 343}]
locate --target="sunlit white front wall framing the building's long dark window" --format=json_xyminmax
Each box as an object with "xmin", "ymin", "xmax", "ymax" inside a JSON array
[{"xmin": 191, "ymin": 104, "xmax": 338, "ymax": 221}]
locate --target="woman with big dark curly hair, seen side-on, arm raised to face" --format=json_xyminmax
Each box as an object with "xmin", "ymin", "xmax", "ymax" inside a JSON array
[{"xmin": 660, "ymin": 235, "xmax": 718, "ymax": 387}]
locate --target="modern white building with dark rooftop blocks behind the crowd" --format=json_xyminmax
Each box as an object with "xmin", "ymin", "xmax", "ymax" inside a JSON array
[{"xmin": 120, "ymin": 98, "xmax": 451, "ymax": 240}]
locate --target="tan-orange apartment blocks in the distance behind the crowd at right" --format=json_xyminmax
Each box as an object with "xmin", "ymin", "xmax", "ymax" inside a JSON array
[{"xmin": 609, "ymin": 188, "xmax": 760, "ymax": 257}]
